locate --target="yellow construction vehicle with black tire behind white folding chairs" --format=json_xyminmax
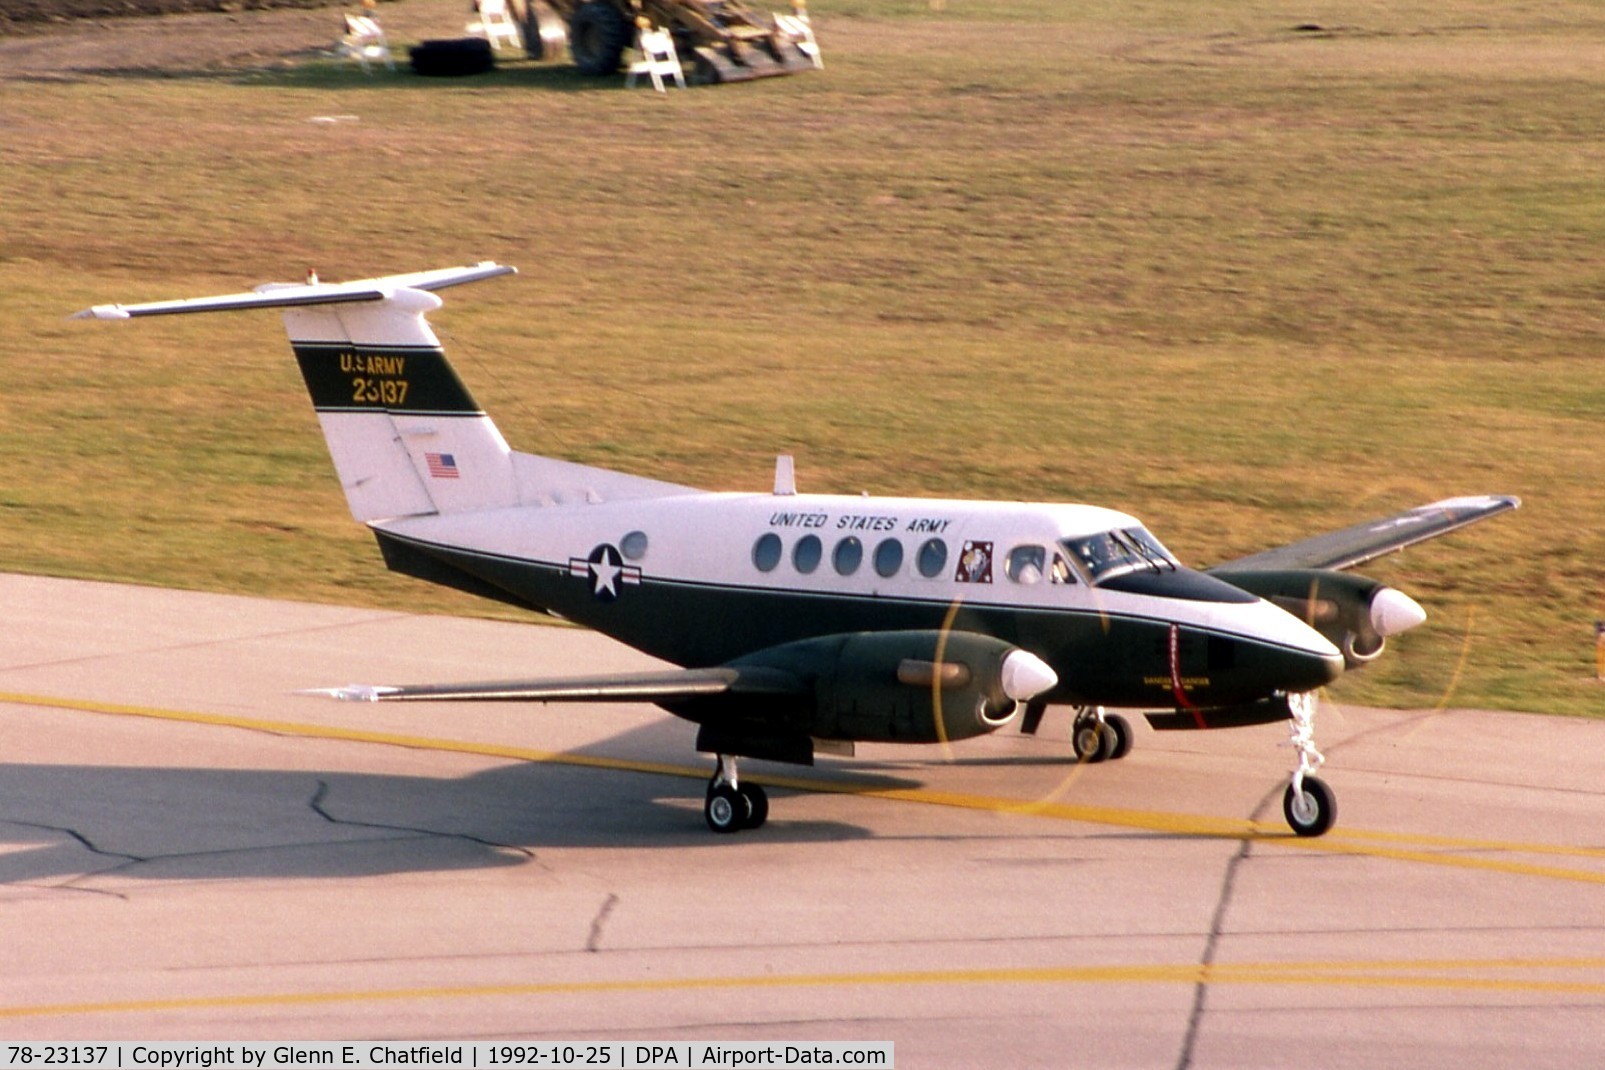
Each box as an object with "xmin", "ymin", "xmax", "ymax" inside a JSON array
[{"xmin": 509, "ymin": 0, "xmax": 822, "ymax": 83}]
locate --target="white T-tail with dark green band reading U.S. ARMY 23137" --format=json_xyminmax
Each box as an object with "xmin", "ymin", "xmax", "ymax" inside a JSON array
[{"xmin": 79, "ymin": 261, "xmax": 687, "ymax": 523}]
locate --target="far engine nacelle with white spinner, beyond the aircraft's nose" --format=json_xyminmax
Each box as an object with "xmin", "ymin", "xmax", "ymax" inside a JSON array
[{"xmin": 1210, "ymin": 568, "xmax": 1427, "ymax": 669}]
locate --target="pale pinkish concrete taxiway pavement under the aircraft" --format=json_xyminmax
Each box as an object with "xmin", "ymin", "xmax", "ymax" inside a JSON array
[{"xmin": 0, "ymin": 574, "xmax": 1605, "ymax": 1070}]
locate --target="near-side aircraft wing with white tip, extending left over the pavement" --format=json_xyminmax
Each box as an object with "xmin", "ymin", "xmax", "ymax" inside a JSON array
[{"xmin": 305, "ymin": 666, "xmax": 807, "ymax": 703}]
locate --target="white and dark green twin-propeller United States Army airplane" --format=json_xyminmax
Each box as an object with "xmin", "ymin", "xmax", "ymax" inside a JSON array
[{"xmin": 79, "ymin": 261, "xmax": 1520, "ymax": 836}]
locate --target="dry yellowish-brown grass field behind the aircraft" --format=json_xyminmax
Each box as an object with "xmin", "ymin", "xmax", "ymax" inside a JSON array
[{"xmin": 0, "ymin": 0, "xmax": 1605, "ymax": 714}]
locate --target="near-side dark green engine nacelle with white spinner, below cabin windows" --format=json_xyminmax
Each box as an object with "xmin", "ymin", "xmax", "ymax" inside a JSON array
[{"xmin": 732, "ymin": 630, "xmax": 1058, "ymax": 743}]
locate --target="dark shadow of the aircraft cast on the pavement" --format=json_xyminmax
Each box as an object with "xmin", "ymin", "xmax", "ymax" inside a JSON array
[{"xmin": 0, "ymin": 712, "xmax": 950, "ymax": 886}]
